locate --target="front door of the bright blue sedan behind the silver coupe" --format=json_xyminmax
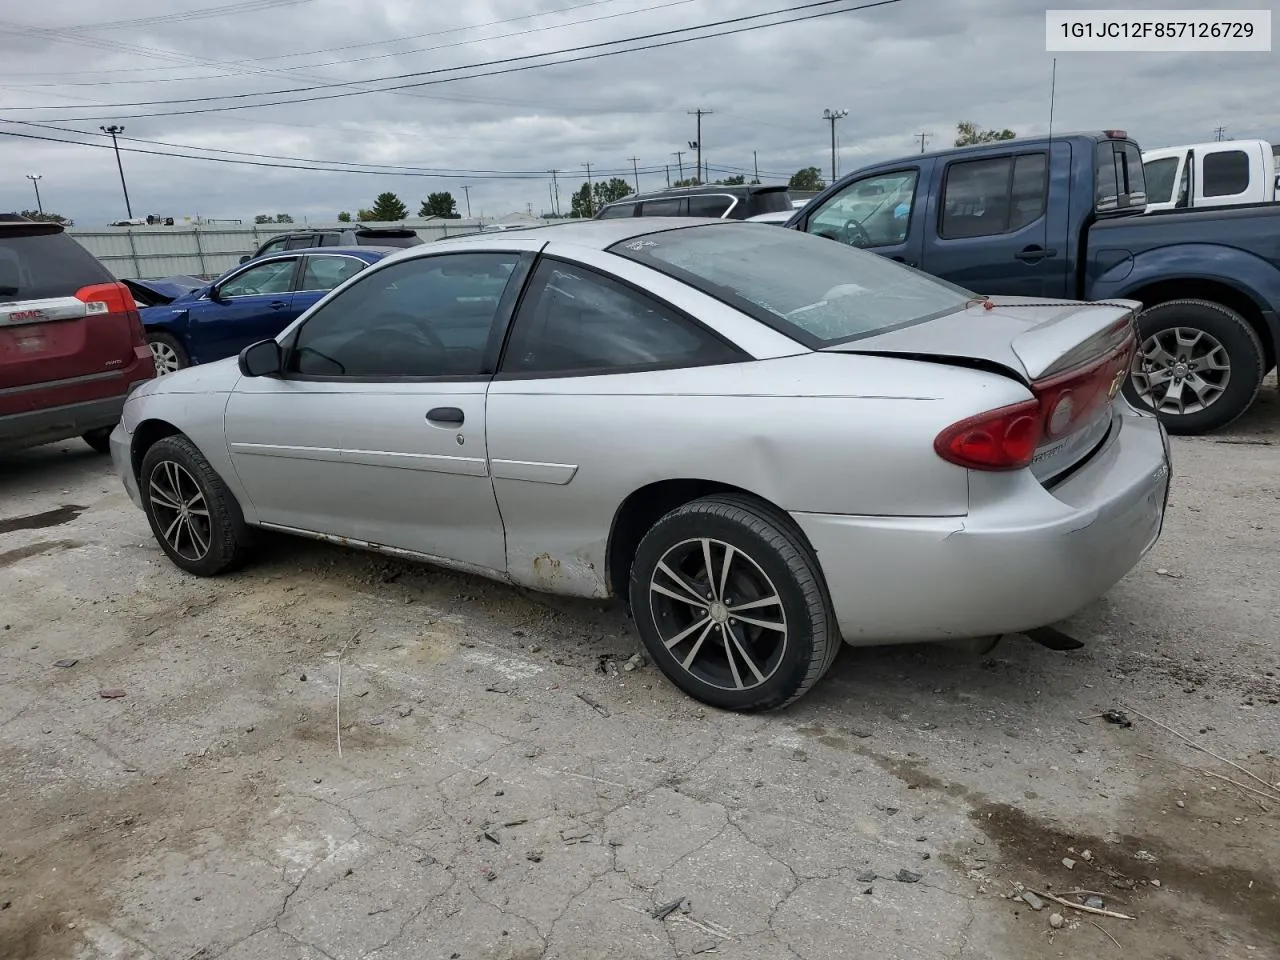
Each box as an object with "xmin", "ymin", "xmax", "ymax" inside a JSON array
[{"xmin": 187, "ymin": 256, "xmax": 298, "ymax": 364}]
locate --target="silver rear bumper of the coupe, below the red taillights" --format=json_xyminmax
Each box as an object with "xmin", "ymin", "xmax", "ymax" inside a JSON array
[{"xmin": 792, "ymin": 404, "xmax": 1170, "ymax": 645}]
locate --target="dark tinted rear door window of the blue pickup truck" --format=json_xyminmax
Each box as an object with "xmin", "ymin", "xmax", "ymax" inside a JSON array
[{"xmin": 938, "ymin": 154, "xmax": 1047, "ymax": 239}]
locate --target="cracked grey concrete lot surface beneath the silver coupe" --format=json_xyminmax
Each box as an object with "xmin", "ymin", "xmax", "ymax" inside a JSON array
[{"xmin": 0, "ymin": 384, "xmax": 1280, "ymax": 960}]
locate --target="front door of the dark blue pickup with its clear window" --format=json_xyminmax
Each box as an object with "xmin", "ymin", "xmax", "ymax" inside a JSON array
[{"xmin": 799, "ymin": 166, "xmax": 933, "ymax": 266}]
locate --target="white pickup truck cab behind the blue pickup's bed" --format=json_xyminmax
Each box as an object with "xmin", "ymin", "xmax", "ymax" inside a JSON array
[{"xmin": 1142, "ymin": 140, "xmax": 1280, "ymax": 214}]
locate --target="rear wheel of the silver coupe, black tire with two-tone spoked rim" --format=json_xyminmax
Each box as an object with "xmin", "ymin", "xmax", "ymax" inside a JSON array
[{"xmin": 630, "ymin": 495, "xmax": 841, "ymax": 710}]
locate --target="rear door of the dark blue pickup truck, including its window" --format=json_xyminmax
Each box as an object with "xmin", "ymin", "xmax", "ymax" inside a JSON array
[{"xmin": 920, "ymin": 142, "xmax": 1071, "ymax": 297}]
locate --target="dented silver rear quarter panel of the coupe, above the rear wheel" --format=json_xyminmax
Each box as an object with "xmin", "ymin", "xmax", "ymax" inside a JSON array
[{"xmin": 486, "ymin": 353, "xmax": 1029, "ymax": 596}]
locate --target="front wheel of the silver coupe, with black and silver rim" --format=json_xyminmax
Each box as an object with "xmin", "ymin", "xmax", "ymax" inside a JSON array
[{"xmin": 138, "ymin": 435, "xmax": 250, "ymax": 577}]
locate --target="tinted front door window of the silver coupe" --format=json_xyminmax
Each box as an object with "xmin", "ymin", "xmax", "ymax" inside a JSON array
[{"xmin": 288, "ymin": 253, "xmax": 520, "ymax": 379}]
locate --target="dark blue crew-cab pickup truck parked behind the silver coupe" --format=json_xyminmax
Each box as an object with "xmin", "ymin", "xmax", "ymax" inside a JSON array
[{"xmin": 787, "ymin": 131, "xmax": 1280, "ymax": 434}]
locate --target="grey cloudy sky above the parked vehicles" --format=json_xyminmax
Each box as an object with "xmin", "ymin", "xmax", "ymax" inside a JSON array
[{"xmin": 0, "ymin": 0, "xmax": 1280, "ymax": 225}]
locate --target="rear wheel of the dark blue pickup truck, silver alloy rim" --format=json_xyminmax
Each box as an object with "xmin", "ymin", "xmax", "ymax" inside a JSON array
[{"xmin": 1124, "ymin": 300, "xmax": 1265, "ymax": 434}]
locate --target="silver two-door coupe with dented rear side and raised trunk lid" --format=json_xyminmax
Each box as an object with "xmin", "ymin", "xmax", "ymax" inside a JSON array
[{"xmin": 111, "ymin": 218, "xmax": 1169, "ymax": 710}]
